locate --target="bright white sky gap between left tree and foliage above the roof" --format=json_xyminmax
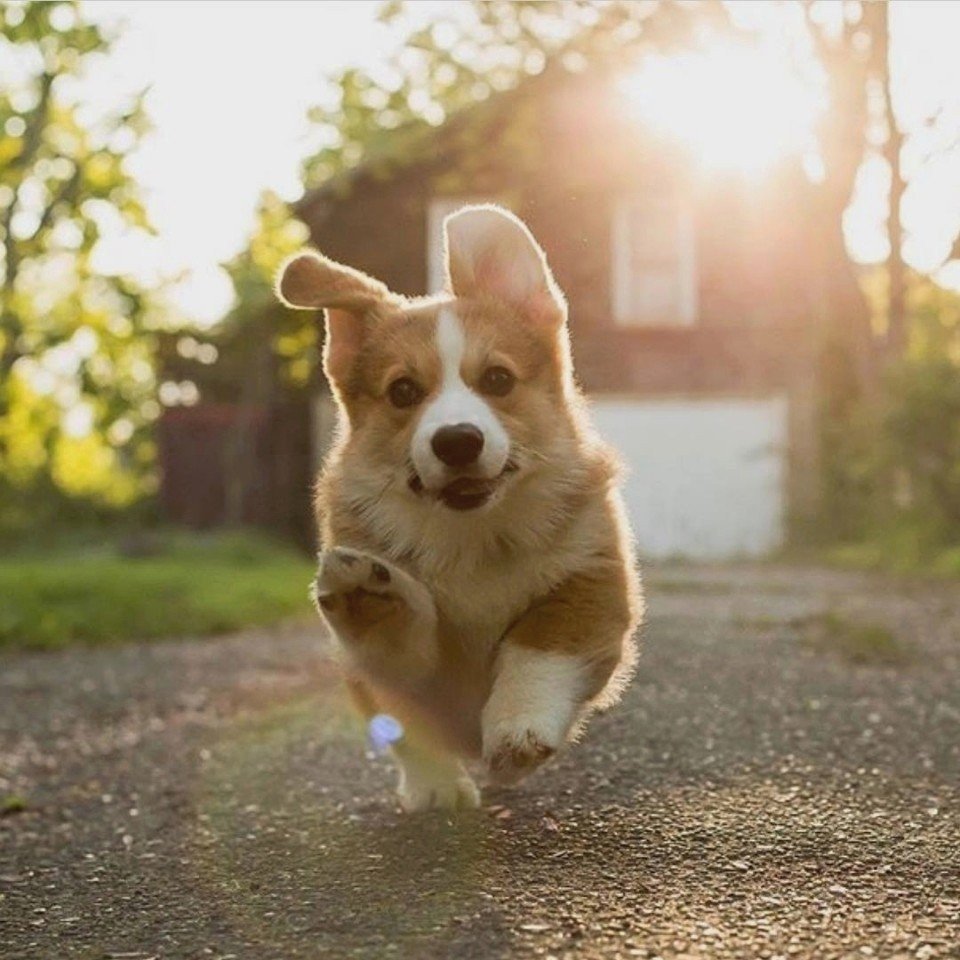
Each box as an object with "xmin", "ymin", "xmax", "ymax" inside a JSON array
[{"xmin": 84, "ymin": 0, "xmax": 389, "ymax": 321}]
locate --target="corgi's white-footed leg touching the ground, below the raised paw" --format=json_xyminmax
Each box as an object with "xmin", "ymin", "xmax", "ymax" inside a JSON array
[{"xmin": 347, "ymin": 677, "xmax": 480, "ymax": 813}]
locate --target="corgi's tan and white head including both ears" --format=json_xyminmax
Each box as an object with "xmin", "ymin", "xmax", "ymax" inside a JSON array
[{"xmin": 278, "ymin": 206, "xmax": 576, "ymax": 511}]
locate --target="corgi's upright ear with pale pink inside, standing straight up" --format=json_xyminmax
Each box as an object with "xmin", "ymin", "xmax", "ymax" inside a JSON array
[{"xmin": 443, "ymin": 204, "xmax": 566, "ymax": 322}]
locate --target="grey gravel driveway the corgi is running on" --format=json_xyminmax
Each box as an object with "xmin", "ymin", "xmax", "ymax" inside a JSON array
[{"xmin": 0, "ymin": 567, "xmax": 960, "ymax": 960}]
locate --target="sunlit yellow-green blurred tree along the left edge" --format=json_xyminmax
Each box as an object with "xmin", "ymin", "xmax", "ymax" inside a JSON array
[{"xmin": 0, "ymin": 2, "xmax": 159, "ymax": 524}]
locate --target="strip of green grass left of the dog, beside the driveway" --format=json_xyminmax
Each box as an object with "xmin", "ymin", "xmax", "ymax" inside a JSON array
[{"xmin": 0, "ymin": 533, "xmax": 313, "ymax": 649}]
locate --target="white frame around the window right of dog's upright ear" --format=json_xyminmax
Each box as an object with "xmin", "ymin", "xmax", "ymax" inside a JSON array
[{"xmin": 612, "ymin": 194, "xmax": 699, "ymax": 328}]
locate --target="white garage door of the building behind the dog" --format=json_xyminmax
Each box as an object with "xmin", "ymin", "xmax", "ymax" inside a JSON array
[{"xmin": 591, "ymin": 397, "xmax": 787, "ymax": 559}]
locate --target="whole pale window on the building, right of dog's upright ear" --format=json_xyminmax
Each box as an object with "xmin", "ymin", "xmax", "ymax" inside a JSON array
[{"xmin": 613, "ymin": 194, "xmax": 697, "ymax": 327}]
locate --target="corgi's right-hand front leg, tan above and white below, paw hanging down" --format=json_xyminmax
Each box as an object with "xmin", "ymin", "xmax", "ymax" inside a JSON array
[{"xmin": 482, "ymin": 563, "xmax": 639, "ymax": 784}]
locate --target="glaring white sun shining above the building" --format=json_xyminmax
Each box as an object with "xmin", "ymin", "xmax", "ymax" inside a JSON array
[{"xmin": 622, "ymin": 46, "xmax": 821, "ymax": 175}]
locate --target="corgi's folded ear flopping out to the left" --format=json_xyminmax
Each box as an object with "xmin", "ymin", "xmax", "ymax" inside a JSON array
[{"xmin": 277, "ymin": 250, "xmax": 396, "ymax": 383}]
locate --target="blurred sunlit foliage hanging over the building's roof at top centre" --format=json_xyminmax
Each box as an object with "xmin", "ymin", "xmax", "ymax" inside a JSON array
[{"xmin": 304, "ymin": 0, "xmax": 731, "ymax": 190}]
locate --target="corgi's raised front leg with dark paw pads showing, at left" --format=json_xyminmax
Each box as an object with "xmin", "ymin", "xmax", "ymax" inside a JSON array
[{"xmin": 314, "ymin": 547, "xmax": 437, "ymax": 689}]
